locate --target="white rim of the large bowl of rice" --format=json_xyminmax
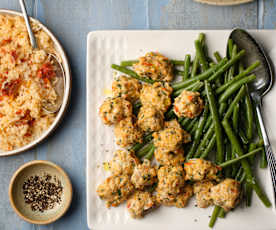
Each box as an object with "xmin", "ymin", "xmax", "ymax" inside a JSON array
[{"xmin": 0, "ymin": 8, "xmax": 72, "ymax": 157}]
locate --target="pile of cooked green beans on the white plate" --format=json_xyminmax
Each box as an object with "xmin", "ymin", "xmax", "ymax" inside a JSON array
[{"xmin": 111, "ymin": 33, "xmax": 271, "ymax": 227}]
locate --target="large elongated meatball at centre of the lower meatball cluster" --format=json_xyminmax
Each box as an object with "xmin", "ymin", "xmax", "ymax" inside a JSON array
[{"xmin": 156, "ymin": 165, "xmax": 185, "ymax": 205}]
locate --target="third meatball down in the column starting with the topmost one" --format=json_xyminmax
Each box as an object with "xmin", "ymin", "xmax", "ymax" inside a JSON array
[{"xmin": 138, "ymin": 105, "xmax": 164, "ymax": 132}]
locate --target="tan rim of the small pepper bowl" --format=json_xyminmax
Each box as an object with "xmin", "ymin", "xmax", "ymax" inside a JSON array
[{"xmin": 9, "ymin": 160, "xmax": 73, "ymax": 225}]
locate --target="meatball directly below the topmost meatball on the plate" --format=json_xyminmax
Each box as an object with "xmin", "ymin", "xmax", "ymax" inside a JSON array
[{"xmin": 140, "ymin": 82, "xmax": 172, "ymax": 113}]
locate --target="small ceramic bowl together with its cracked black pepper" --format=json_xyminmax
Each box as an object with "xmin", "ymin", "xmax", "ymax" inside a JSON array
[{"xmin": 9, "ymin": 160, "xmax": 73, "ymax": 224}]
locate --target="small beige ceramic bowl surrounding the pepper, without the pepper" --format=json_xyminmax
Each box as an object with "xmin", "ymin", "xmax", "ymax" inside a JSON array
[{"xmin": 9, "ymin": 160, "xmax": 73, "ymax": 224}]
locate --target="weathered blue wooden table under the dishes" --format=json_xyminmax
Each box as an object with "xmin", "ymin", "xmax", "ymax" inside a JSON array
[{"xmin": 0, "ymin": 0, "xmax": 276, "ymax": 230}]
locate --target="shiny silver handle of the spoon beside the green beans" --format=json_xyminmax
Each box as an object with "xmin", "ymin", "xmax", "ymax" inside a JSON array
[{"xmin": 256, "ymin": 103, "xmax": 276, "ymax": 204}]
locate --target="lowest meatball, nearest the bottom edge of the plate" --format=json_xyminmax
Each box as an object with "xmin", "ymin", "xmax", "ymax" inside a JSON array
[{"xmin": 127, "ymin": 191, "xmax": 156, "ymax": 218}]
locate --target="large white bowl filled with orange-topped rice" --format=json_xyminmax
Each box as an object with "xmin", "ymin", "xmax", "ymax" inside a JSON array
[{"xmin": 0, "ymin": 9, "xmax": 71, "ymax": 156}]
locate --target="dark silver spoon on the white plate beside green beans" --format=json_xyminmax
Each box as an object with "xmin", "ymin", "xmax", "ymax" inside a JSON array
[{"xmin": 230, "ymin": 29, "xmax": 276, "ymax": 203}]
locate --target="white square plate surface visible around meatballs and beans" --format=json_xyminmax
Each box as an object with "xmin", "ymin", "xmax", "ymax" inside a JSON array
[{"xmin": 87, "ymin": 30, "xmax": 276, "ymax": 230}]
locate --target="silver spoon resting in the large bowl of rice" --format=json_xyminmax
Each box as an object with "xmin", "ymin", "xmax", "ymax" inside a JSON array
[{"xmin": 19, "ymin": 0, "xmax": 65, "ymax": 113}]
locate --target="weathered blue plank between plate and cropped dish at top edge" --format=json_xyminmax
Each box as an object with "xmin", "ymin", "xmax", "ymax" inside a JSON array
[{"xmin": 149, "ymin": 0, "xmax": 257, "ymax": 29}]
